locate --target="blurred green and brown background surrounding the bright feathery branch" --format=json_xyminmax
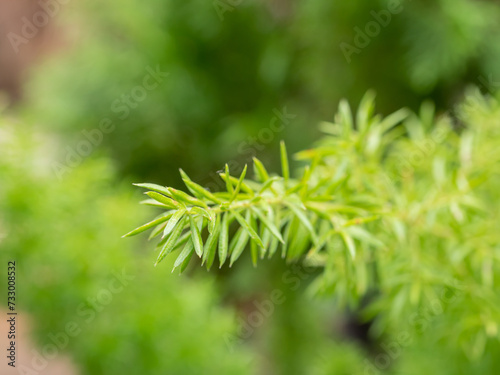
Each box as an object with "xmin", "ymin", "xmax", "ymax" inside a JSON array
[{"xmin": 0, "ymin": 0, "xmax": 500, "ymax": 375}]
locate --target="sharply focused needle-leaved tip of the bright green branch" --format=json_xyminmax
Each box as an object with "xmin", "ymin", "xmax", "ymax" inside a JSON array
[{"xmin": 124, "ymin": 138, "xmax": 378, "ymax": 272}]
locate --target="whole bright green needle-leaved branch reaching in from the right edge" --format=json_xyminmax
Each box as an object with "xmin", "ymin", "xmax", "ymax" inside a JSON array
[{"xmin": 127, "ymin": 92, "xmax": 500, "ymax": 374}]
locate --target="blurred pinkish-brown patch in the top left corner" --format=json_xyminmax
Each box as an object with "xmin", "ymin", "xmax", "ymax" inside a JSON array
[{"xmin": 0, "ymin": 0, "xmax": 58, "ymax": 105}]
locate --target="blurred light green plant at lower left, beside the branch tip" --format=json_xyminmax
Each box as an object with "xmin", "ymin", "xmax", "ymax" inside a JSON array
[{"xmin": 0, "ymin": 119, "xmax": 251, "ymax": 375}]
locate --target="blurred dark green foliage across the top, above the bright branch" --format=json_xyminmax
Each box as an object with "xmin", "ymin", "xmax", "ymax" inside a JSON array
[{"xmin": 23, "ymin": 0, "xmax": 500, "ymax": 186}]
